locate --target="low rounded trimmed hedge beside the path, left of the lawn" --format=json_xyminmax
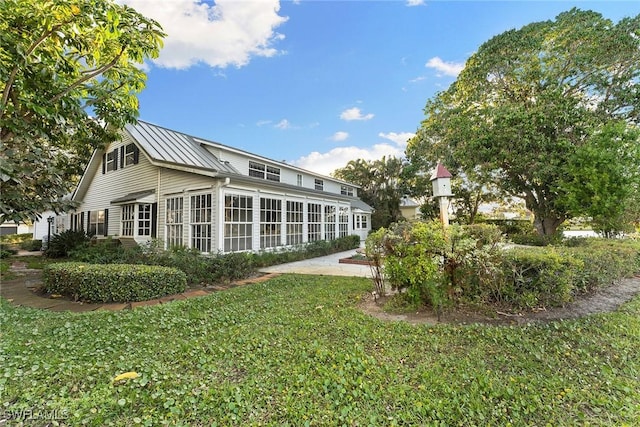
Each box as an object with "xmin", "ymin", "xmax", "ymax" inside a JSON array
[{"xmin": 43, "ymin": 262, "xmax": 187, "ymax": 302}]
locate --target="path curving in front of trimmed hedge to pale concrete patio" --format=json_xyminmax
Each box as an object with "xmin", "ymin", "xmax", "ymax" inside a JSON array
[{"xmin": 0, "ymin": 250, "xmax": 371, "ymax": 312}]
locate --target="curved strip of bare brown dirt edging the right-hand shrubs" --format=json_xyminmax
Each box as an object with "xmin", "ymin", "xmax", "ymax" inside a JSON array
[{"xmin": 360, "ymin": 275, "xmax": 640, "ymax": 325}]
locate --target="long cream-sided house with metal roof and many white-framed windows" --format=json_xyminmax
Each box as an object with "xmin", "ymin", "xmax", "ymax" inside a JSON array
[{"xmin": 60, "ymin": 121, "xmax": 372, "ymax": 253}]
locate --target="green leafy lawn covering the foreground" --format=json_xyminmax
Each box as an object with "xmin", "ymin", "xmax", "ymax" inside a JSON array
[{"xmin": 0, "ymin": 276, "xmax": 640, "ymax": 426}]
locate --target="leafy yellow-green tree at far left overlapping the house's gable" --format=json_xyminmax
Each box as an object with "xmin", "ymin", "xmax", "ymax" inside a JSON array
[{"xmin": 0, "ymin": 0, "xmax": 165, "ymax": 223}]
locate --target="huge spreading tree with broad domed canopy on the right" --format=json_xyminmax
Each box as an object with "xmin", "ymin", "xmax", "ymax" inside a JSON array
[{"xmin": 407, "ymin": 9, "xmax": 640, "ymax": 235}]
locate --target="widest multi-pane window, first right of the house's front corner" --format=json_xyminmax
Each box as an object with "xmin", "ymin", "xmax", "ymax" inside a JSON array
[{"xmin": 224, "ymin": 194, "xmax": 253, "ymax": 252}]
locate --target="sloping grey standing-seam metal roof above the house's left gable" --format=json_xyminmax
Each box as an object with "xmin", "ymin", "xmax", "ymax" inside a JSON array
[{"xmin": 125, "ymin": 120, "xmax": 239, "ymax": 174}]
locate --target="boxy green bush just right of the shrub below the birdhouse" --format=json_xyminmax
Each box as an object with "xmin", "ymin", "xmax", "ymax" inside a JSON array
[{"xmin": 498, "ymin": 247, "xmax": 584, "ymax": 308}]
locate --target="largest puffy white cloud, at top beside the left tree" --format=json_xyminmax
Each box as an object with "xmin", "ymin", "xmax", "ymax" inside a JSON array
[{"xmin": 120, "ymin": 0, "xmax": 288, "ymax": 69}]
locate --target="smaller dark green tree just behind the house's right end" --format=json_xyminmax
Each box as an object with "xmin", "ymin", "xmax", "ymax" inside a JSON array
[{"xmin": 332, "ymin": 157, "xmax": 404, "ymax": 230}]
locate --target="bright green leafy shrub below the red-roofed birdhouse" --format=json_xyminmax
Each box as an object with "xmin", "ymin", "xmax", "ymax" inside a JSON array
[{"xmin": 366, "ymin": 221, "xmax": 502, "ymax": 315}]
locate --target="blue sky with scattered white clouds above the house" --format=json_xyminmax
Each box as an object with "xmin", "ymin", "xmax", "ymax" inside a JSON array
[{"xmin": 120, "ymin": 0, "xmax": 640, "ymax": 175}]
